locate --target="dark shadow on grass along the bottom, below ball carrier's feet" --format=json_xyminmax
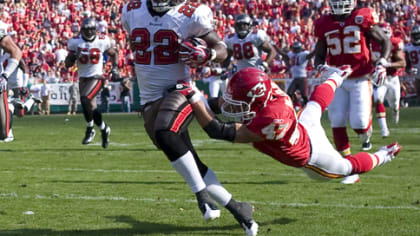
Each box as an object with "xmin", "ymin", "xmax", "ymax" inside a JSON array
[{"xmin": 0, "ymin": 215, "xmax": 296, "ymax": 236}]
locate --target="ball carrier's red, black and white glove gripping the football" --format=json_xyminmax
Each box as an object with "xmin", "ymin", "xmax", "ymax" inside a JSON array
[{"xmin": 179, "ymin": 38, "xmax": 216, "ymax": 68}]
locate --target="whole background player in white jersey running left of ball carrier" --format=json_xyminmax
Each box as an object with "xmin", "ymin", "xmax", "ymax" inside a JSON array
[{"xmin": 65, "ymin": 18, "xmax": 118, "ymax": 148}]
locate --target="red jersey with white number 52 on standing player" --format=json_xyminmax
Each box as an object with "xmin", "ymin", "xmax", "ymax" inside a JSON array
[{"xmin": 315, "ymin": 8, "xmax": 378, "ymax": 78}]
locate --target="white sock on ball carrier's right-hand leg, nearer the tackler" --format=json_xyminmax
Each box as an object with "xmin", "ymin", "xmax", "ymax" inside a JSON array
[{"xmin": 204, "ymin": 168, "xmax": 232, "ymax": 206}]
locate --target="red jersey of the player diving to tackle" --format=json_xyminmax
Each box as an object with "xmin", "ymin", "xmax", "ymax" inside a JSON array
[{"xmin": 247, "ymin": 89, "xmax": 311, "ymax": 167}]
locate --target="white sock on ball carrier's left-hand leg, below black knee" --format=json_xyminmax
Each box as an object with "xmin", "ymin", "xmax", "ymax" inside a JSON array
[{"xmin": 171, "ymin": 151, "xmax": 206, "ymax": 193}]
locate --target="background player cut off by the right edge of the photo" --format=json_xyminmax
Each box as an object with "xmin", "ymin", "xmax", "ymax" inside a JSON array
[{"xmin": 404, "ymin": 25, "xmax": 420, "ymax": 105}]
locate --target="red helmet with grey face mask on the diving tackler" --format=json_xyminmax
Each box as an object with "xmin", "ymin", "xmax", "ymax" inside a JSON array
[{"xmin": 222, "ymin": 67, "xmax": 272, "ymax": 122}]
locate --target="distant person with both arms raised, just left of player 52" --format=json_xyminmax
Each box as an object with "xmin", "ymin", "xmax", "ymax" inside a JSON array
[{"xmin": 278, "ymin": 41, "xmax": 315, "ymax": 107}]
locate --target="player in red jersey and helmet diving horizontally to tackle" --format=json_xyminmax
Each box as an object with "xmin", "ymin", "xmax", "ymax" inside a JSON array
[{"xmin": 173, "ymin": 65, "xmax": 401, "ymax": 186}]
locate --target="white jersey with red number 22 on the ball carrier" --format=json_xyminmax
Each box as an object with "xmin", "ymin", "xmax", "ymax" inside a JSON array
[{"xmin": 121, "ymin": 0, "xmax": 213, "ymax": 105}]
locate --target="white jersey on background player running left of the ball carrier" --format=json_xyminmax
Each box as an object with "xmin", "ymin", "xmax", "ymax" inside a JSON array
[{"xmin": 67, "ymin": 35, "xmax": 111, "ymax": 77}]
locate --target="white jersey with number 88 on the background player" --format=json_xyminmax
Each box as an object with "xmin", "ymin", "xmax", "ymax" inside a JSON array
[{"xmin": 225, "ymin": 30, "xmax": 270, "ymax": 70}]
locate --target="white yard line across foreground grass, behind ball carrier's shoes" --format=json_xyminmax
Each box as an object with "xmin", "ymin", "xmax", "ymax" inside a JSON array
[{"xmin": 0, "ymin": 192, "xmax": 420, "ymax": 211}]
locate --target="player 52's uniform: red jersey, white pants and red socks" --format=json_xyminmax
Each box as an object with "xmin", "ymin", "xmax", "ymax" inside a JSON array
[{"xmin": 315, "ymin": 8, "xmax": 378, "ymax": 156}]
